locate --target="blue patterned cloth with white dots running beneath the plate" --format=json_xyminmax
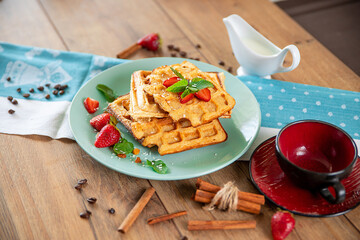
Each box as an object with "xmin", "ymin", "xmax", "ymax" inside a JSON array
[{"xmin": 0, "ymin": 42, "xmax": 360, "ymax": 139}]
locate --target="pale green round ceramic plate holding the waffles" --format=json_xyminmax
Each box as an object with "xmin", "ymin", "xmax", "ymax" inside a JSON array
[{"xmin": 70, "ymin": 58, "xmax": 261, "ymax": 180}]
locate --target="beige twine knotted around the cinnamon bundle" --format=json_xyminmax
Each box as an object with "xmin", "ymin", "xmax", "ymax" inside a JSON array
[{"xmin": 205, "ymin": 182, "xmax": 239, "ymax": 211}]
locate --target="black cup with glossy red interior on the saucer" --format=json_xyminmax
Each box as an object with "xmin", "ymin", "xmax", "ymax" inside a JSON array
[{"xmin": 276, "ymin": 120, "xmax": 357, "ymax": 203}]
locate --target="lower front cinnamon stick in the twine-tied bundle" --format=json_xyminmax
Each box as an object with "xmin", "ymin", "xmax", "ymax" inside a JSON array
[{"xmin": 194, "ymin": 189, "xmax": 261, "ymax": 214}]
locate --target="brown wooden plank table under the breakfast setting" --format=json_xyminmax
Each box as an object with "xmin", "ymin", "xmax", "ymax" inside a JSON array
[{"xmin": 0, "ymin": 0, "xmax": 360, "ymax": 239}]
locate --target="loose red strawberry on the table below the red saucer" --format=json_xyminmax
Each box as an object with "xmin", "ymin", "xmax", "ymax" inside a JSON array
[{"xmin": 271, "ymin": 211, "xmax": 295, "ymax": 240}]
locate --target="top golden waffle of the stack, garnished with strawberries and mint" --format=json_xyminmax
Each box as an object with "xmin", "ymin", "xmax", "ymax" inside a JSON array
[{"xmin": 144, "ymin": 61, "xmax": 235, "ymax": 127}]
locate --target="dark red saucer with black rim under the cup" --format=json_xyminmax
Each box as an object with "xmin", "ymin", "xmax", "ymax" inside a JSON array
[{"xmin": 250, "ymin": 137, "xmax": 360, "ymax": 217}]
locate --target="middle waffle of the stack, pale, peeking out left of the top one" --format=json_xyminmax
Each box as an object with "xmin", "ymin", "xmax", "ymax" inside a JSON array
[{"xmin": 130, "ymin": 71, "xmax": 168, "ymax": 119}]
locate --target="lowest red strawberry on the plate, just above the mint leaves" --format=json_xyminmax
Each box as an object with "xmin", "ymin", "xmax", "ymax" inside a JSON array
[{"xmin": 94, "ymin": 124, "xmax": 121, "ymax": 148}]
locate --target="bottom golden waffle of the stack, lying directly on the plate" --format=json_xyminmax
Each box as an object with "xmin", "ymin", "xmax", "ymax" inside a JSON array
[{"xmin": 108, "ymin": 95, "xmax": 227, "ymax": 155}]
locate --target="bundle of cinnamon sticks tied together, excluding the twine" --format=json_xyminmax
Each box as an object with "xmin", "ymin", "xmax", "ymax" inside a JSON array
[{"xmin": 193, "ymin": 178, "xmax": 265, "ymax": 214}]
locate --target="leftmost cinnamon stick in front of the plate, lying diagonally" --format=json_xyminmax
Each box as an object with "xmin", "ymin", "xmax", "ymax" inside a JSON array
[{"xmin": 118, "ymin": 187, "xmax": 155, "ymax": 233}]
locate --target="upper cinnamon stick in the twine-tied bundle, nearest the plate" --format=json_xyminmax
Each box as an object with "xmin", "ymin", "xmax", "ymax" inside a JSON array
[{"xmin": 196, "ymin": 178, "xmax": 265, "ymax": 205}]
